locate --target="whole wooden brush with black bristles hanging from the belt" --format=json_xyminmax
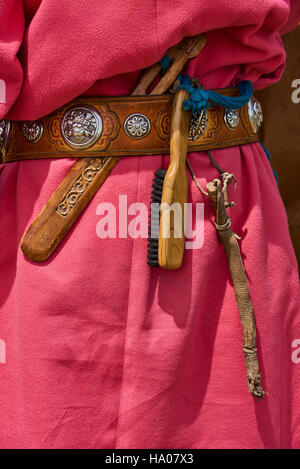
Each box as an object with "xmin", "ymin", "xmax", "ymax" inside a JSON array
[{"xmin": 147, "ymin": 89, "xmax": 191, "ymax": 270}]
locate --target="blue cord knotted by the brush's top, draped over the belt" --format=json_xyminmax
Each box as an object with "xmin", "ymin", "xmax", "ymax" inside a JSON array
[{"xmin": 178, "ymin": 75, "xmax": 253, "ymax": 112}]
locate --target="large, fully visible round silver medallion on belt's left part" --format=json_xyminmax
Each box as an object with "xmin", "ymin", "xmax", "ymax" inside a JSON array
[{"xmin": 61, "ymin": 106, "xmax": 102, "ymax": 149}]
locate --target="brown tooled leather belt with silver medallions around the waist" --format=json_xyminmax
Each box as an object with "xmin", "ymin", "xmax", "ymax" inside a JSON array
[{"xmin": 0, "ymin": 88, "xmax": 260, "ymax": 163}]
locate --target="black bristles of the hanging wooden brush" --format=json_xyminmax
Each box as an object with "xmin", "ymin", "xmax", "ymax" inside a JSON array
[{"xmin": 147, "ymin": 169, "xmax": 167, "ymax": 267}]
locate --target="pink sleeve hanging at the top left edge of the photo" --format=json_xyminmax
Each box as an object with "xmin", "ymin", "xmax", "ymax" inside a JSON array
[{"xmin": 0, "ymin": 0, "xmax": 25, "ymax": 119}]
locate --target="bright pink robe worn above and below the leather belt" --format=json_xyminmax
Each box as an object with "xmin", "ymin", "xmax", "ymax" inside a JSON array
[{"xmin": 0, "ymin": 0, "xmax": 300, "ymax": 448}]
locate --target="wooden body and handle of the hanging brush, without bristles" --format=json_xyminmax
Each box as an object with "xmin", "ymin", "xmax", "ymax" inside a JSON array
[{"xmin": 158, "ymin": 89, "xmax": 191, "ymax": 270}]
